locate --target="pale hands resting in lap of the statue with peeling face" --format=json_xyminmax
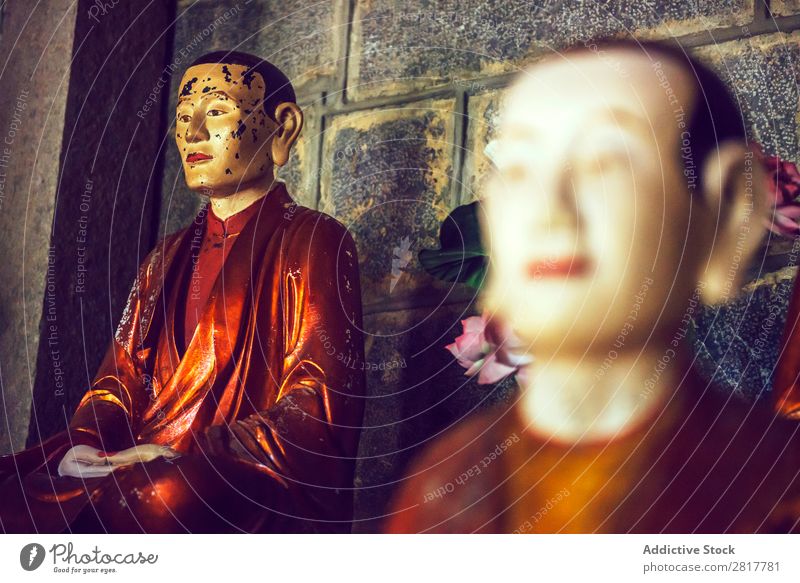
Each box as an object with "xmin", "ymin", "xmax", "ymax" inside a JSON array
[{"xmin": 58, "ymin": 443, "xmax": 180, "ymax": 478}]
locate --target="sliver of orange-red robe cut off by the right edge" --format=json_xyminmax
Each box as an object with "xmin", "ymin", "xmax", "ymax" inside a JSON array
[{"xmin": 772, "ymin": 280, "xmax": 800, "ymax": 419}]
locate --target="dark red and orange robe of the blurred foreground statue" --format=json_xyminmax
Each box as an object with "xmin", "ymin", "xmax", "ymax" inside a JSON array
[{"xmin": 385, "ymin": 373, "xmax": 800, "ymax": 533}]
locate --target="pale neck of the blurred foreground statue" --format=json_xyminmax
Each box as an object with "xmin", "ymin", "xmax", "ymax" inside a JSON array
[{"xmin": 519, "ymin": 343, "xmax": 685, "ymax": 443}]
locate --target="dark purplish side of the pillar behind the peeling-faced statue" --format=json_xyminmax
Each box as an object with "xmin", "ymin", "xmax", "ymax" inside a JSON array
[{"xmin": 28, "ymin": 0, "xmax": 177, "ymax": 445}]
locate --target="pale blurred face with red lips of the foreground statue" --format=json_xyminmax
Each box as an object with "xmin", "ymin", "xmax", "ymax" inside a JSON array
[{"xmin": 484, "ymin": 49, "xmax": 707, "ymax": 353}]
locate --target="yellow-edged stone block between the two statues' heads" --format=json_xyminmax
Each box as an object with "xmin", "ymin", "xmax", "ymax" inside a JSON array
[{"xmin": 320, "ymin": 99, "xmax": 455, "ymax": 309}]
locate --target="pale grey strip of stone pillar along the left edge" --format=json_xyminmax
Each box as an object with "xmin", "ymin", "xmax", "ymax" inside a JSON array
[{"xmin": 0, "ymin": 0, "xmax": 76, "ymax": 454}]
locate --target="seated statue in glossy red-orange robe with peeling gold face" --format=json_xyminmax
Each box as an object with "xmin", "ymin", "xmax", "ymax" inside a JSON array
[{"xmin": 0, "ymin": 51, "xmax": 364, "ymax": 533}]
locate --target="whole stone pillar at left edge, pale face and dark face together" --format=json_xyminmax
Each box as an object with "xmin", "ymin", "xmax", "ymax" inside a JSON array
[{"xmin": 0, "ymin": 0, "xmax": 174, "ymax": 454}]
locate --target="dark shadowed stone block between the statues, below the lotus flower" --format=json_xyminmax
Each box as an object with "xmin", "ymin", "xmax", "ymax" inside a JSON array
[{"xmin": 353, "ymin": 304, "xmax": 516, "ymax": 532}]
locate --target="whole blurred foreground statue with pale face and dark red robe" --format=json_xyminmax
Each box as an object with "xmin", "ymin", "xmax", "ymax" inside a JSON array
[{"xmin": 385, "ymin": 40, "xmax": 800, "ymax": 533}]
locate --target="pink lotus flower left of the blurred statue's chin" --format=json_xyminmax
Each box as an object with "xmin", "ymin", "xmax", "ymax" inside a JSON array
[{"xmin": 446, "ymin": 313, "xmax": 533, "ymax": 385}]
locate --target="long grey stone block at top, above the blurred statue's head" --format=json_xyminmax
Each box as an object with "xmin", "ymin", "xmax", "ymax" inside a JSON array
[{"xmin": 348, "ymin": 0, "xmax": 753, "ymax": 100}]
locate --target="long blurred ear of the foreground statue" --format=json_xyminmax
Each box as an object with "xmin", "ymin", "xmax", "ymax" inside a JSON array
[{"xmin": 700, "ymin": 142, "xmax": 769, "ymax": 304}]
